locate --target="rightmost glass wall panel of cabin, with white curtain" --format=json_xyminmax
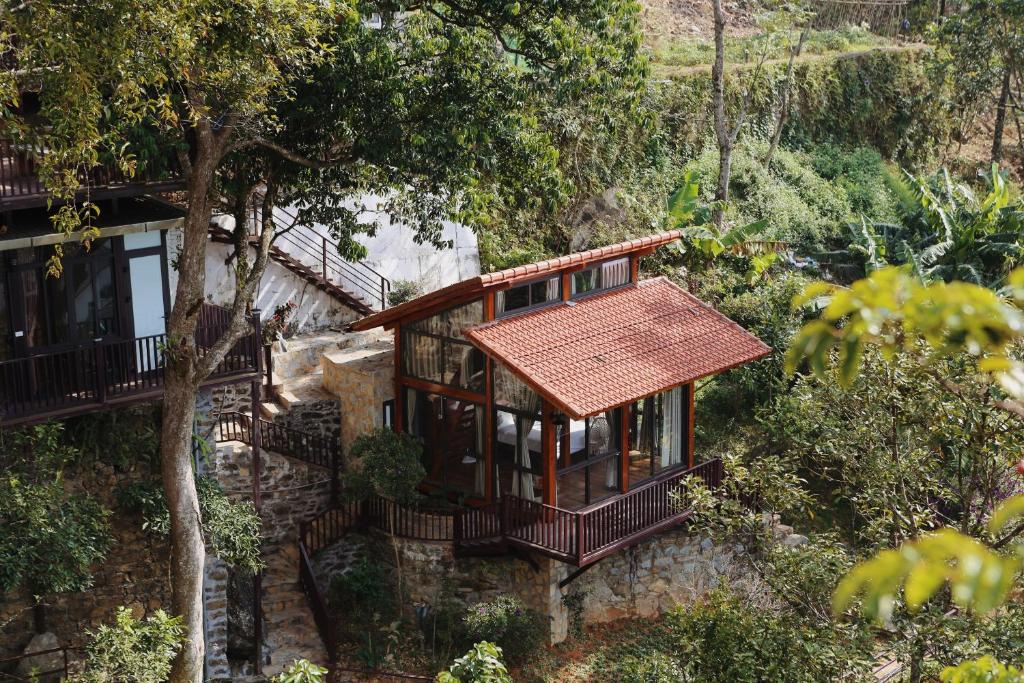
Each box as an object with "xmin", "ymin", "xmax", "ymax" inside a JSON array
[{"xmin": 629, "ymin": 386, "xmax": 690, "ymax": 487}]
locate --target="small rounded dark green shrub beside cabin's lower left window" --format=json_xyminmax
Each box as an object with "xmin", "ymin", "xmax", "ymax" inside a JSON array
[{"xmin": 343, "ymin": 428, "xmax": 427, "ymax": 503}]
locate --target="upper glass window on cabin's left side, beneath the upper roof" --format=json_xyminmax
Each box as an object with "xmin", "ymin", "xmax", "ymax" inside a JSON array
[{"xmin": 401, "ymin": 300, "xmax": 485, "ymax": 392}]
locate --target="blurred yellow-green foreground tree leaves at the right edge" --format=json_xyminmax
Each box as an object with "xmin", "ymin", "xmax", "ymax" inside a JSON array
[{"xmin": 790, "ymin": 268, "xmax": 1024, "ymax": 681}]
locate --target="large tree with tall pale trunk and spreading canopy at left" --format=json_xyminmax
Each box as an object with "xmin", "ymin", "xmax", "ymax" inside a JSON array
[{"xmin": 6, "ymin": 0, "xmax": 642, "ymax": 682}]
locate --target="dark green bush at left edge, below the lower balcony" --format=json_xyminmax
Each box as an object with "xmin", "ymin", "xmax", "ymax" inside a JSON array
[{"xmin": 0, "ymin": 423, "xmax": 112, "ymax": 595}]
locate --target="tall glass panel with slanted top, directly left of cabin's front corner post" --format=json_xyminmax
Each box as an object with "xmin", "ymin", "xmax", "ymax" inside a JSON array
[{"xmin": 494, "ymin": 362, "xmax": 544, "ymax": 502}]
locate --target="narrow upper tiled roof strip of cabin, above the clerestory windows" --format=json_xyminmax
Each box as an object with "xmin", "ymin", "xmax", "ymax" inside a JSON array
[{"xmin": 349, "ymin": 230, "xmax": 682, "ymax": 331}]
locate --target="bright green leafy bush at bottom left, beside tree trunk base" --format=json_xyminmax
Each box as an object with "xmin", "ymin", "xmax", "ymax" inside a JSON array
[{"xmin": 72, "ymin": 607, "xmax": 185, "ymax": 683}]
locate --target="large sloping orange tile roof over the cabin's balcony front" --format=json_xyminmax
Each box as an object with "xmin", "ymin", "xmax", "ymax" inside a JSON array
[{"xmin": 466, "ymin": 278, "xmax": 771, "ymax": 420}]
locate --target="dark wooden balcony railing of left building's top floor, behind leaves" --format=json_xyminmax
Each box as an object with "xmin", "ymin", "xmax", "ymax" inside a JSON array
[{"xmin": 0, "ymin": 139, "xmax": 184, "ymax": 211}]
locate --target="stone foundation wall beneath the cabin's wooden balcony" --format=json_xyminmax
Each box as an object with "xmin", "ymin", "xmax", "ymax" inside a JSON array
[{"xmin": 317, "ymin": 527, "xmax": 758, "ymax": 643}]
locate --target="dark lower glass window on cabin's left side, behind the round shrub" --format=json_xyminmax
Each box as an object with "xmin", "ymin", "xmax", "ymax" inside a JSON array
[{"xmin": 406, "ymin": 389, "xmax": 485, "ymax": 498}]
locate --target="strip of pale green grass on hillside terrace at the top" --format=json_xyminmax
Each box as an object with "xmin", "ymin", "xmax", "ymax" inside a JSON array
[{"xmin": 653, "ymin": 27, "xmax": 892, "ymax": 67}]
